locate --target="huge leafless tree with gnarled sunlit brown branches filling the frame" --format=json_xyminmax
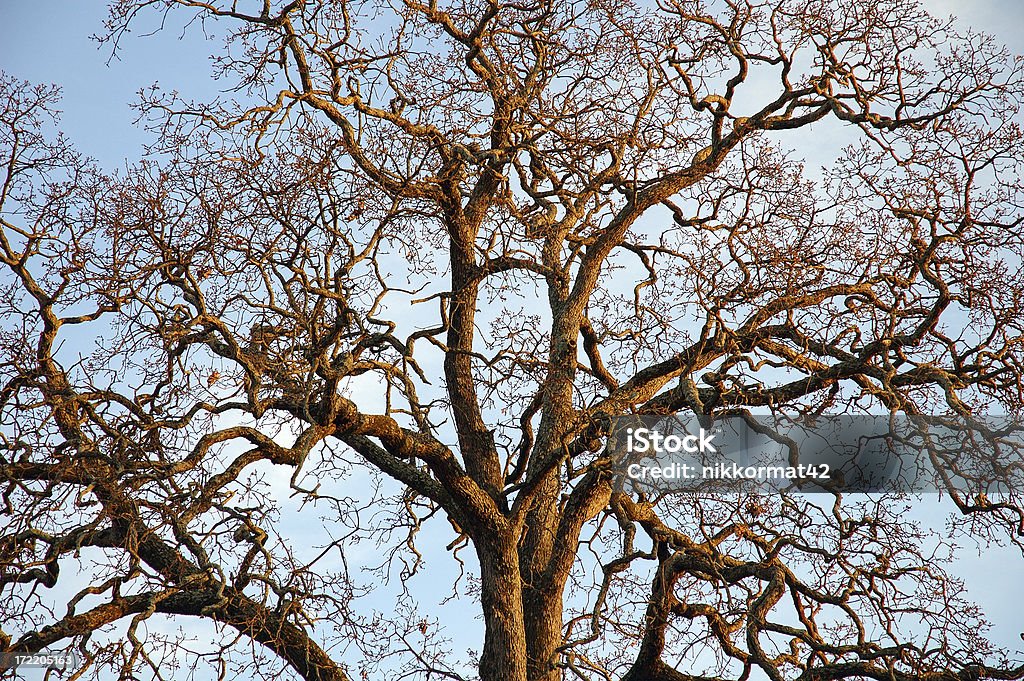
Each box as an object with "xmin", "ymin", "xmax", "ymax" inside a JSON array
[{"xmin": 0, "ymin": 0, "xmax": 1024, "ymax": 681}]
